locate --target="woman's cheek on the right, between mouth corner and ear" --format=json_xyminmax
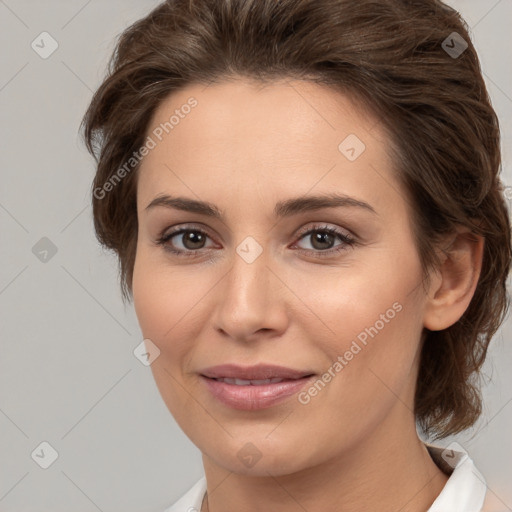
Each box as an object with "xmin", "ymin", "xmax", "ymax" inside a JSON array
[{"xmin": 296, "ymin": 250, "xmax": 422, "ymax": 409}]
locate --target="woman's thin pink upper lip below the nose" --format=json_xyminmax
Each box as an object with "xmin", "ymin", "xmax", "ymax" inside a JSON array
[{"xmin": 199, "ymin": 364, "xmax": 313, "ymax": 380}]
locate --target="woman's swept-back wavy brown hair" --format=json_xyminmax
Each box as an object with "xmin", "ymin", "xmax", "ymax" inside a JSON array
[{"xmin": 82, "ymin": 0, "xmax": 511, "ymax": 439}]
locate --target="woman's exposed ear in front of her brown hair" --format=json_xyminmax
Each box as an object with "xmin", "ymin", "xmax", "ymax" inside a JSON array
[{"xmin": 423, "ymin": 228, "xmax": 484, "ymax": 331}]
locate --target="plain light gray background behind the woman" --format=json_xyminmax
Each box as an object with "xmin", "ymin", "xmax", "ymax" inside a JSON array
[{"xmin": 0, "ymin": 0, "xmax": 512, "ymax": 512}]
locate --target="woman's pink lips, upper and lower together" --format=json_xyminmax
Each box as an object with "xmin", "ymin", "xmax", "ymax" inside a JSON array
[{"xmin": 199, "ymin": 364, "xmax": 314, "ymax": 411}]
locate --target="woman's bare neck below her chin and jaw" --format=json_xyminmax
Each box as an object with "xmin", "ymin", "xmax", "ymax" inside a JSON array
[{"xmin": 201, "ymin": 404, "xmax": 448, "ymax": 512}]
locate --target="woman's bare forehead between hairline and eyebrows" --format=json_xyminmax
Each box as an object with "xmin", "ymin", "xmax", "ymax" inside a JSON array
[{"xmin": 138, "ymin": 79, "xmax": 400, "ymax": 216}]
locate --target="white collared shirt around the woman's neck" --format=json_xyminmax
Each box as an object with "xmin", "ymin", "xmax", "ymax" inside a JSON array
[{"xmin": 164, "ymin": 444, "xmax": 487, "ymax": 512}]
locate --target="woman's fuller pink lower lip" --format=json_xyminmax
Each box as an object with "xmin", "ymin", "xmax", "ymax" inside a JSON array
[{"xmin": 201, "ymin": 375, "xmax": 313, "ymax": 411}]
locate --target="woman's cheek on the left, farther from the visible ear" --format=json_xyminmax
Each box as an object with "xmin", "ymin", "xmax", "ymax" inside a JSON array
[{"xmin": 132, "ymin": 244, "xmax": 218, "ymax": 404}]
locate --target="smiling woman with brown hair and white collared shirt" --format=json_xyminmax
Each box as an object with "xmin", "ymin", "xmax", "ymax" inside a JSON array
[{"xmin": 84, "ymin": 0, "xmax": 511, "ymax": 512}]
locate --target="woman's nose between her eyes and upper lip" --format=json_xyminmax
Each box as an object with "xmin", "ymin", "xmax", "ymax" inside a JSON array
[{"xmin": 213, "ymin": 245, "xmax": 289, "ymax": 342}]
